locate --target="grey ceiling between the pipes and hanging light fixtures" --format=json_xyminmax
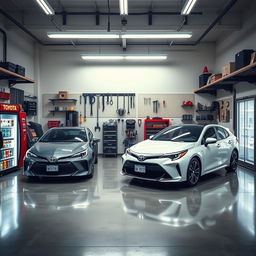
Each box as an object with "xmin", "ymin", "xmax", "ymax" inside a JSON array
[{"xmin": 0, "ymin": 0, "xmax": 252, "ymax": 44}]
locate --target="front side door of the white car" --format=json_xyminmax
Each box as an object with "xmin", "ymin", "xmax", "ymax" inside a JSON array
[{"xmin": 201, "ymin": 127, "xmax": 219, "ymax": 174}]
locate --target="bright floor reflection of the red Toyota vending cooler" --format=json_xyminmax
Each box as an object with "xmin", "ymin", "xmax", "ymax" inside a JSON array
[{"xmin": 0, "ymin": 176, "xmax": 18, "ymax": 238}]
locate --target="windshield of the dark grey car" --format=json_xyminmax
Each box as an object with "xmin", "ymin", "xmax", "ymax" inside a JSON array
[{"xmin": 40, "ymin": 129, "xmax": 87, "ymax": 142}]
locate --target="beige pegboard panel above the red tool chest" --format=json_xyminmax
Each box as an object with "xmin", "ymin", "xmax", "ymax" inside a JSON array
[{"xmin": 138, "ymin": 94, "xmax": 195, "ymax": 118}]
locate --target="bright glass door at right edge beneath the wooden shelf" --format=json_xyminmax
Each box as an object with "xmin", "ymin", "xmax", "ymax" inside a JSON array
[{"xmin": 237, "ymin": 99, "xmax": 255, "ymax": 166}]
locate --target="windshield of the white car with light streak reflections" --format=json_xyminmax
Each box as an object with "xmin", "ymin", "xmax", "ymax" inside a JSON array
[{"xmin": 152, "ymin": 125, "xmax": 203, "ymax": 142}]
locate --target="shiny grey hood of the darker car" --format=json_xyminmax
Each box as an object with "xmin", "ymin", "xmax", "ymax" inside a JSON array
[{"xmin": 30, "ymin": 142, "xmax": 88, "ymax": 158}]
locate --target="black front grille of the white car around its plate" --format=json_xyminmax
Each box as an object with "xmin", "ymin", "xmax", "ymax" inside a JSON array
[{"xmin": 123, "ymin": 161, "xmax": 172, "ymax": 180}]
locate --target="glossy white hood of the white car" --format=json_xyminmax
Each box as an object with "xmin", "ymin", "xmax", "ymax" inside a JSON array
[{"xmin": 131, "ymin": 140, "xmax": 195, "ymax": 155}]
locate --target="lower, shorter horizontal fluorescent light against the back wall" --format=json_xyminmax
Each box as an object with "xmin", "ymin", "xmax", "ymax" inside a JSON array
[{"xmin": 81, "ymin": 54, "xmax": 167, "ymax": 61}]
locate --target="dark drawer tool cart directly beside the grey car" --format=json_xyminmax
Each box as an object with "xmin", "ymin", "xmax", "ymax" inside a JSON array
[{"xmin": 103, "ymin": 122, "xmax": 117, "ymax": 156}]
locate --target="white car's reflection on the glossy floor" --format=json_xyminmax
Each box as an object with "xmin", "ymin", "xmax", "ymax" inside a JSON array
[{"xmin": 121, "ymin": 174, "xmax": 239, "ymax": 230}]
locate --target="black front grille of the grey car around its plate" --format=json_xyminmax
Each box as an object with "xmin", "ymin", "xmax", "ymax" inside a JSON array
[{"xmin": 30, "ymin": 162, "xmax": 77, "ymax": 176}]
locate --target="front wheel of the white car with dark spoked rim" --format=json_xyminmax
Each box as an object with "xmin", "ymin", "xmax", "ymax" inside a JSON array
[{"xmin": 187, "ymin": 157, "xmax": 201, "ymax": 187}]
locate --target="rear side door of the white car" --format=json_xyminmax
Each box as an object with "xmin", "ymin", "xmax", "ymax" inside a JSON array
[{"xmin": 215, "ymin": 126, "xmax": 232, "ymax": 165}]
